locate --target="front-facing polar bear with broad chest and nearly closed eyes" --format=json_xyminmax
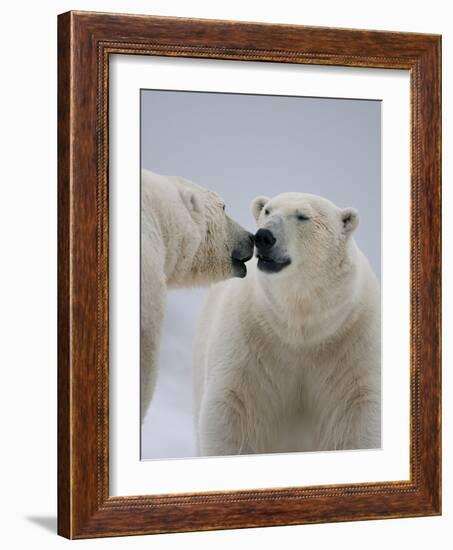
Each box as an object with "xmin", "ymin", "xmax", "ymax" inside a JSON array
[{"xmin": 194, "ymin": 193, "xmax": 381, "ymax": 456}]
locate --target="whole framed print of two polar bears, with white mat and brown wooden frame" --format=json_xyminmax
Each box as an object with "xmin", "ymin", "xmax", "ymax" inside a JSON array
[{"xmin": 58, "ymin": 12, "xmax": 441, "ymax": 538}]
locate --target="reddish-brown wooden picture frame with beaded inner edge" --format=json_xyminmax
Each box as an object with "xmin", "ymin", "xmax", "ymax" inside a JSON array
[{"xmin": 58, "ymin": 12, "xmax": 441, "ymax": 538}]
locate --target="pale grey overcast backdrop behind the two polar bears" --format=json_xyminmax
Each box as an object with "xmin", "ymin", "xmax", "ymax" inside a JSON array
[{"xmin": 141, "ymin": 90, "xmax": 381, "ymax": 459}]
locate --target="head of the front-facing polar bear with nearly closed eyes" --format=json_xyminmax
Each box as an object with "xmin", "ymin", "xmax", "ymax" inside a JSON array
[{"xmin": 252, "ymin": 193, "xmax": 359, "ymax": 286}]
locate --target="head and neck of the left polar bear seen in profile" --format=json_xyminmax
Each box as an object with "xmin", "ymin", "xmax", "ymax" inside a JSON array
[{"xmin": 141, "ymin": 170, "xmax": 253, "ymax": 288}]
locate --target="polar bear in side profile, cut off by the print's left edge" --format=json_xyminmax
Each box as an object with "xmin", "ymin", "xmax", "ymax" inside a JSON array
[{"xmin": 140, "ymin": 170, "xmax": 253, "ymax": 422}]
